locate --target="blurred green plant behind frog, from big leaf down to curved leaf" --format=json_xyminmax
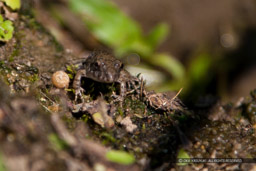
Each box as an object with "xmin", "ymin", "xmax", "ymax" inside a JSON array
[{"xmin": 69, "ymin": 0, "xmax": 185, "ymax": 89}]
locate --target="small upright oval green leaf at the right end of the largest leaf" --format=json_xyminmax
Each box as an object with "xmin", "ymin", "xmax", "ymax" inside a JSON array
[{"xmin": 146, "ymin": 23, "xmax": 169, "ymax": 49}]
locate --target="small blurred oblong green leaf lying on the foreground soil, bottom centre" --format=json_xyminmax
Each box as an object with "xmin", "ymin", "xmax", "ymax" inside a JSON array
[{"xmin": 106, "ymin": 150, "xmax": 135, "ymax": 165}]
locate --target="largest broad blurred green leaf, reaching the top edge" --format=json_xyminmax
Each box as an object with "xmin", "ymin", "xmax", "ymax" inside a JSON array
[{"xmin": 69, "ymin": 0, "xmax": 141, "ymax": 47}]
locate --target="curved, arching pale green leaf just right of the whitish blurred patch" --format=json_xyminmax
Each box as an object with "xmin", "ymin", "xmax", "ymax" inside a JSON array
[{"xmin": 150, "ymin": 54, "xmax": 185, "ymax": 80}]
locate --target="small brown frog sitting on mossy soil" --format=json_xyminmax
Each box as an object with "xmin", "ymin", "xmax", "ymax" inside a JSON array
[{"xmin": 73, "ymin": 51, "xmax": 139, "ymax": 102}]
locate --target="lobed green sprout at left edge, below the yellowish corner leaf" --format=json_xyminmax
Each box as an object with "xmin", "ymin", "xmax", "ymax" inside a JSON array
[{"xmin": 0, "ymin": 15, "xmax": 14, "ymax": 42}]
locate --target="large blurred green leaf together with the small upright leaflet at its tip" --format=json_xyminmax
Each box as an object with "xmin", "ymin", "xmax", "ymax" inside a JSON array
[{"xmin": 69, "ymin": 0, "xmax": 168, "ymax": 58}]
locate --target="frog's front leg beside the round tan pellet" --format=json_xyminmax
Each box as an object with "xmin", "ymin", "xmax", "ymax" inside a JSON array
[{"xmin": 73, "ymin": 69, "xmax": 86, "ymax": 101}]
